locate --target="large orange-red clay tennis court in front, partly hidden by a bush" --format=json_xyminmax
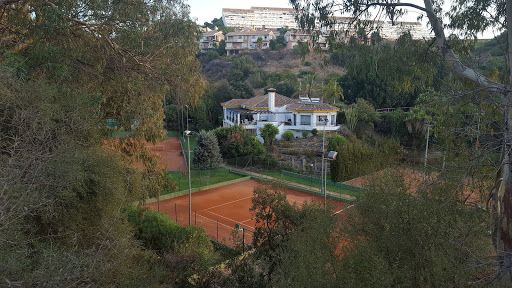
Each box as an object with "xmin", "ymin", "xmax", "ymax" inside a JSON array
[{"xmin": 146, "ymin": 180, "xmax": 345, "ymax": 246}]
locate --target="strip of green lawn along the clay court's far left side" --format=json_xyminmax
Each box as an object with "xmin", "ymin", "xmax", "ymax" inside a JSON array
[{"xmin": 162, "ymin": 168, "xmax": 243, "ymax": 195}]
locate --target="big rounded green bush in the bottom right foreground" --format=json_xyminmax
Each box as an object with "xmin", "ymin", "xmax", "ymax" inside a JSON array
[{"xmin": 337, "ymin": 171, "xmax": 490, "ymax": 287}]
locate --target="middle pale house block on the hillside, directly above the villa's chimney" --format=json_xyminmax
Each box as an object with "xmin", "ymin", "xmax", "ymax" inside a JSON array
[{"xmin": 225, "ymin": 30, "xmax": 279, "ymax": 55}]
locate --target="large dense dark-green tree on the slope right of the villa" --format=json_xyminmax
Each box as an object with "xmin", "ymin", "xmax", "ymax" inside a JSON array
[{"xmin": 333, "ymin": 33, "xmax": 443, "ymax": 108}]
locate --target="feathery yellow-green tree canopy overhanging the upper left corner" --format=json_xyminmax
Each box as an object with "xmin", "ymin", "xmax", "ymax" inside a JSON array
[{"xmin": 0, "ymin": 0, "xmax": 205, "ymax": 140}]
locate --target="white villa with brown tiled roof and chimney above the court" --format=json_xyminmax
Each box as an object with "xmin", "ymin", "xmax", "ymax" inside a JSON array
[{"xmin": 221, "ymin": 88, "xmax": 340, "ymax": 141}]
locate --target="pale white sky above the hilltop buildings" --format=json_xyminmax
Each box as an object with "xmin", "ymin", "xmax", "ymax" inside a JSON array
[{"xmin": 187, "ymin": 0, "xmax": 500, "ymax": 39}]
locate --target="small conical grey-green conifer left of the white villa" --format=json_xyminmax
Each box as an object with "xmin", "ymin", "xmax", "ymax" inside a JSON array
[{"xmin": 193, "ymin": 130, "xmax": 222, "ymax": 169}]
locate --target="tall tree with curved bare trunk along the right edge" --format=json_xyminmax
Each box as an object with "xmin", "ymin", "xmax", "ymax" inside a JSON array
[{"xmin": 290, "ymin": 0, "xmax": 512, "ymax": 278}]
